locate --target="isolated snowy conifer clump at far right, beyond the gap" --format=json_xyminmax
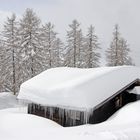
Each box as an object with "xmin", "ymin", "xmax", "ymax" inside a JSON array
[{"xmin": 106, "ymin": 25, "xmax": 133, "ymax": 66}]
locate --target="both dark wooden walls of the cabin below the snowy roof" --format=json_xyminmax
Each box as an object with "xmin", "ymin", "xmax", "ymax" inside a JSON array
[{"xmin": 28, "ymin": 79, "xmax": 140, "ymax": 126}]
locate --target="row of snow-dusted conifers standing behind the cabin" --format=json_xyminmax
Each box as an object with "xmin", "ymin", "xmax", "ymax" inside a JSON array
[{"xmin": 0, "ymin": 8, "xmax": 134, "ymax": 94}]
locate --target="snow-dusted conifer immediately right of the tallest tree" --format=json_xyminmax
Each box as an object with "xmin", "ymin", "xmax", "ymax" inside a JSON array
[{"xmin": 41, "ymin": 22, "xmax": 59, "ymax": 69}]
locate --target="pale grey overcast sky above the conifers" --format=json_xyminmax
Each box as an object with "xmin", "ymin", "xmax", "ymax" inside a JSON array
[{"xmin": 0, "ymin": 0, "xmax": 140, "ymax": 66}]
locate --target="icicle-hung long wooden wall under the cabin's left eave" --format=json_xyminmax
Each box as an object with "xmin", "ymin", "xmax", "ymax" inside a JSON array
[{"xmin": 28, "ymin": 103, "xmax": 86, "ymax": 127}]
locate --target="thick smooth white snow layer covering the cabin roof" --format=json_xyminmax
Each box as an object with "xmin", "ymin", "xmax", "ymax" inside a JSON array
[{"xmin": 18, "ymin": 66, "xmax": 140, "ymax": 109}]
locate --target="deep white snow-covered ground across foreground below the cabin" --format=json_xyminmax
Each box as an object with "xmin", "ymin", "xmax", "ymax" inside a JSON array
[{"xmin": 0, "ymin": 94, "xmax": 140, "ymax": 140}]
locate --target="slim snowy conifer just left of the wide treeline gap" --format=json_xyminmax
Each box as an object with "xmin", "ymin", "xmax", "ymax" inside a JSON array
[{"xmin": 86, "ymin": 25, "xmax": 101, "ymax": 68}]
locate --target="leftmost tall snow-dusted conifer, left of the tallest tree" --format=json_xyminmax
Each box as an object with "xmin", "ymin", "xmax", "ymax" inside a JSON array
[{"xmin": 1, "ymin": 14, "xmax": 19, "ymax": 94}]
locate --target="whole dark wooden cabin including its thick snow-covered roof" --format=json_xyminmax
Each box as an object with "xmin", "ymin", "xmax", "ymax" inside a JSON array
[{"xmin": 18, "ymin": 66, "xmax": 140, "ymax": 126}]
